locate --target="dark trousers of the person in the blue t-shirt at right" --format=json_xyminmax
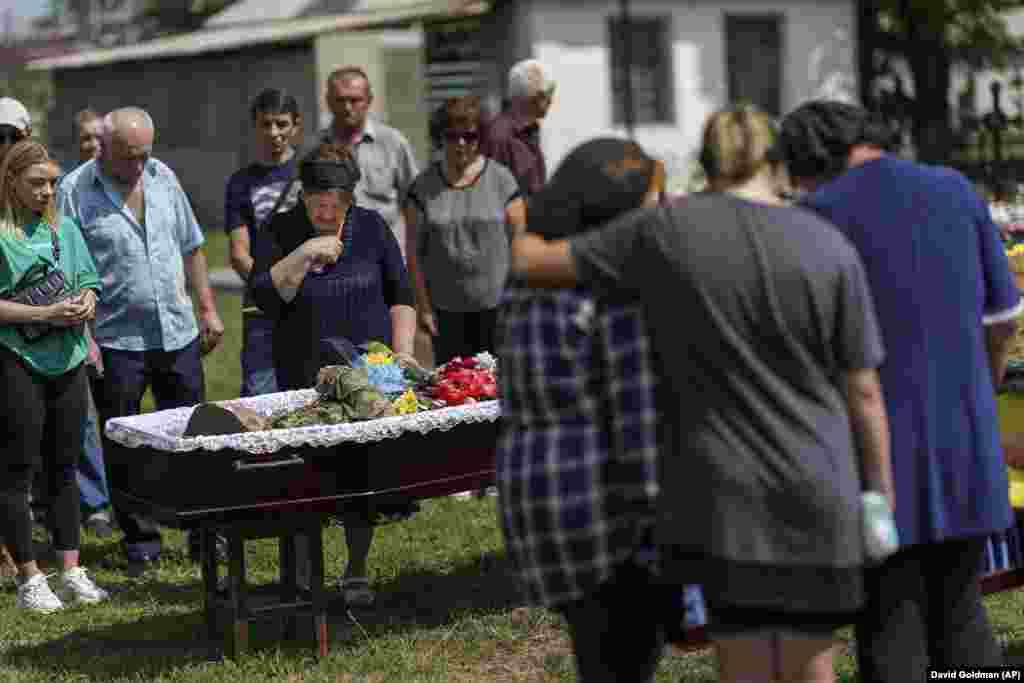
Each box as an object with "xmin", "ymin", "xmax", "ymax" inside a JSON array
[{"xmin": 856, "ymin": 538, "xmax": 1002, "ymax": 683}]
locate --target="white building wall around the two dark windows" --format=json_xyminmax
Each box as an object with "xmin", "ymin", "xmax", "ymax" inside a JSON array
[{"xmin": 528, "ymin": 0, "xmax": 857, "ymax": 189}]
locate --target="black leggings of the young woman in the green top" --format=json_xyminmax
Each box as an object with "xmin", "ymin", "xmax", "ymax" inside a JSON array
[{"xmin": 0, "ymin": 349, "xmax": 88, "ymax": 564}]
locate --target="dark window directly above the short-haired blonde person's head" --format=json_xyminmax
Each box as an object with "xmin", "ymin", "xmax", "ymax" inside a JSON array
[{"xmin": 725, "ymin": 14, "xmax": 782, "ymax": 116}]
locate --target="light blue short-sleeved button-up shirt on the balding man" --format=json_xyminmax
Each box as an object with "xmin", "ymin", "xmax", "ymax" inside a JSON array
[{"xmin": 57, "ymin": 159, "xmax": 204, "ymax": 351}]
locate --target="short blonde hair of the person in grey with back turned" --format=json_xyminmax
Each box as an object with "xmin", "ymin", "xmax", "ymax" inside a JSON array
[{"xmin": 700, "ymin": 105, "xmax": 776, "ymax": 185}]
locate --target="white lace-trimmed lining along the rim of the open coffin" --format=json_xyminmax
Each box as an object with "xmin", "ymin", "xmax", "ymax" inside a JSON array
[{"xmin": 106, "ymin": 389, "xmax": 501, "ymax": 454}]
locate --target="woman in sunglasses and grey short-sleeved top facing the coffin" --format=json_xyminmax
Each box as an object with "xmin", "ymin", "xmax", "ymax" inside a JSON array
[{"xmin": 403, "ymin": 97, "xmax": 525, "ymax": 365}]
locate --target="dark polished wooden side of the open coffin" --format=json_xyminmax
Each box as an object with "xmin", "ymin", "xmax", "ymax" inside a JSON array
[{"xmin": 104, "ymin": 422, "xmax": 498, "ymax": 525}]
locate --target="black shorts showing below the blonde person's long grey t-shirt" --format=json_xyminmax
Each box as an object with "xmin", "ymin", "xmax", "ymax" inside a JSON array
[{"xmin": 707, "ymin": 604, "xmax": 856, "ymax": 640}]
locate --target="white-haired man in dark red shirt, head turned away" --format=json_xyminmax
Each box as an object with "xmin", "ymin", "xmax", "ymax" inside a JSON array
[{"xmin": 481, "ymin": 59, "xmax": 555, "ymax": 196}]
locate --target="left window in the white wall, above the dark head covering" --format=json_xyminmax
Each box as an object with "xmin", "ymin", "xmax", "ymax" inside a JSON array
[{"xmin": 608, "ymin": 16, "xmax": 676, "ymax": 125}]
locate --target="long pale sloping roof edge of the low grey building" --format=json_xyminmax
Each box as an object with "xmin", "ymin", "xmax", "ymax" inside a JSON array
[{"xmin": 29, "ymin": 0, "xmax": 487, "ymax": 71}]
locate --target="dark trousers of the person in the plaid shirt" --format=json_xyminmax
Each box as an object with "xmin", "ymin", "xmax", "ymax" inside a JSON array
[{"xmin": 558, "ymin": 563, "xmax": 667, "ymax": 683}]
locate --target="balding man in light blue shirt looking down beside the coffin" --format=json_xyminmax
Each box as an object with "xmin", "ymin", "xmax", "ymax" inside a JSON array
[{"xmin": 57, "ymin": 108, "xmax": 224, "ymax": 570}]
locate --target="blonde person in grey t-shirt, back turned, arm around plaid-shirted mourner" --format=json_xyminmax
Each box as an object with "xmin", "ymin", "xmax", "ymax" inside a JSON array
[{"xmin": 513, "ymin": 109, "xmax": 893, "ymax": 682}]
